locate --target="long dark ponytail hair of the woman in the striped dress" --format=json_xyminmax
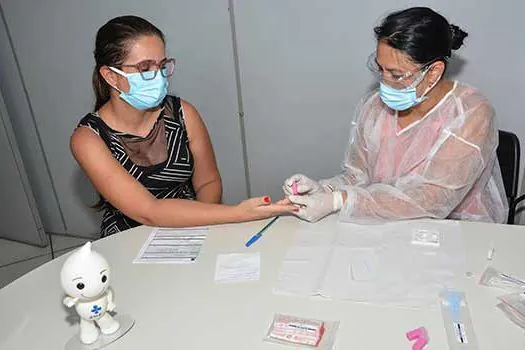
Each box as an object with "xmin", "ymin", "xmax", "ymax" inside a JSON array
[{"xmin": 92, "ymin": 16, "xmax": 165, "ymax": 111}]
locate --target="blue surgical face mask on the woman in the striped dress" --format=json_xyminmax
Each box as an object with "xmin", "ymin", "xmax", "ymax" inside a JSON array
[{"xmin": 109, "ymin": 67, "xmax": 168, "ymax": 111}]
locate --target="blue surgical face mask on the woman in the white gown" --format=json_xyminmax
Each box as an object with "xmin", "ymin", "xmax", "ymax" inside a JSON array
[{"xmin": 379, "ymin": 70, "xmax": 439, "ymax": 111}]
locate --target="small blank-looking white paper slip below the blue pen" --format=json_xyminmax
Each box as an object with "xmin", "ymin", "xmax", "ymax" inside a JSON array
[{"xmin": 215, "ymin": 253, "xmax": 261, "ymax": 283}]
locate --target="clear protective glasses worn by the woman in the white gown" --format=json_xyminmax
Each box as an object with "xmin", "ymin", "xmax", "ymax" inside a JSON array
[{"xmin": 366, "ymin": 53, "xmax": 439, "ymax": 88}]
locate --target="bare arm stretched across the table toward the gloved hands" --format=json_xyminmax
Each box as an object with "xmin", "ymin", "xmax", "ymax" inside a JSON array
[{"xmin": 71, "ymin": 127, "xmax": 293, "ymax": 227}]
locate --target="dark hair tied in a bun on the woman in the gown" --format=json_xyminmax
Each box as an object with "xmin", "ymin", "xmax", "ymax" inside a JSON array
[{"xmin": 374, "ymin": 7, "xmax": 468, "ymax": 64}]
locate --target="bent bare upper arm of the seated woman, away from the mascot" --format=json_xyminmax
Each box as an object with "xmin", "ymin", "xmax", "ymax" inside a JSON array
[{"xmin": 181, "ymin": 100, "xmax": 222, "ymax": 203}]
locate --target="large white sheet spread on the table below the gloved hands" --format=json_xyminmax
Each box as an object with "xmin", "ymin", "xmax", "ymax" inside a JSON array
[{"xmin": 274, "ymin": 220, "xmax": 464, "ymax": 307}]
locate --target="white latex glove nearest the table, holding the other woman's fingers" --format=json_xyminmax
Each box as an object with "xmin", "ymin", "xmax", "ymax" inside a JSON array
[{"xmin": 288, "ymin": 191, "xmax": 343, "ymax": 222}]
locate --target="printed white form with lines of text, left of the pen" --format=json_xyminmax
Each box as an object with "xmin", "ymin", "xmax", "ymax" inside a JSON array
[{"xmin": 133, "ymin": 227, "xmax": 208, "ymax": 264}]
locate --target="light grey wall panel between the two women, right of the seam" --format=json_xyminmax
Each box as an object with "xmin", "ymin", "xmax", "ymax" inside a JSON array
[{"xmin": 235, "ymin": 0, "xmax": 378, "ymax": 197}]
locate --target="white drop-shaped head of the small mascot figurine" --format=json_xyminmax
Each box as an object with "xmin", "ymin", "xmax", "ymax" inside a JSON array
[{"xmin": 60, "ymin": 242, "xmax": 110, "ymax": 300}]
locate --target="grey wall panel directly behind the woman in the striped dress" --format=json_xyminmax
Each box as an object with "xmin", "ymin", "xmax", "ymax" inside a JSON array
[{"xmin": 2, "ymin": 0, "xmax": 246, "ymax": 235}]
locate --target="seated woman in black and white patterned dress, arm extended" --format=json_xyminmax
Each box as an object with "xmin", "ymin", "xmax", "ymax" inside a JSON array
[{"xmin": 71, "ymin": 16, "xmax": 296, "ymax": 236}]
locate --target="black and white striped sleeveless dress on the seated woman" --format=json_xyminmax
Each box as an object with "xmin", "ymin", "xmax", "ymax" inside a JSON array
[{"xmin": 78, "ymin": 96, "xmax": 196, "ymax": 237}]
